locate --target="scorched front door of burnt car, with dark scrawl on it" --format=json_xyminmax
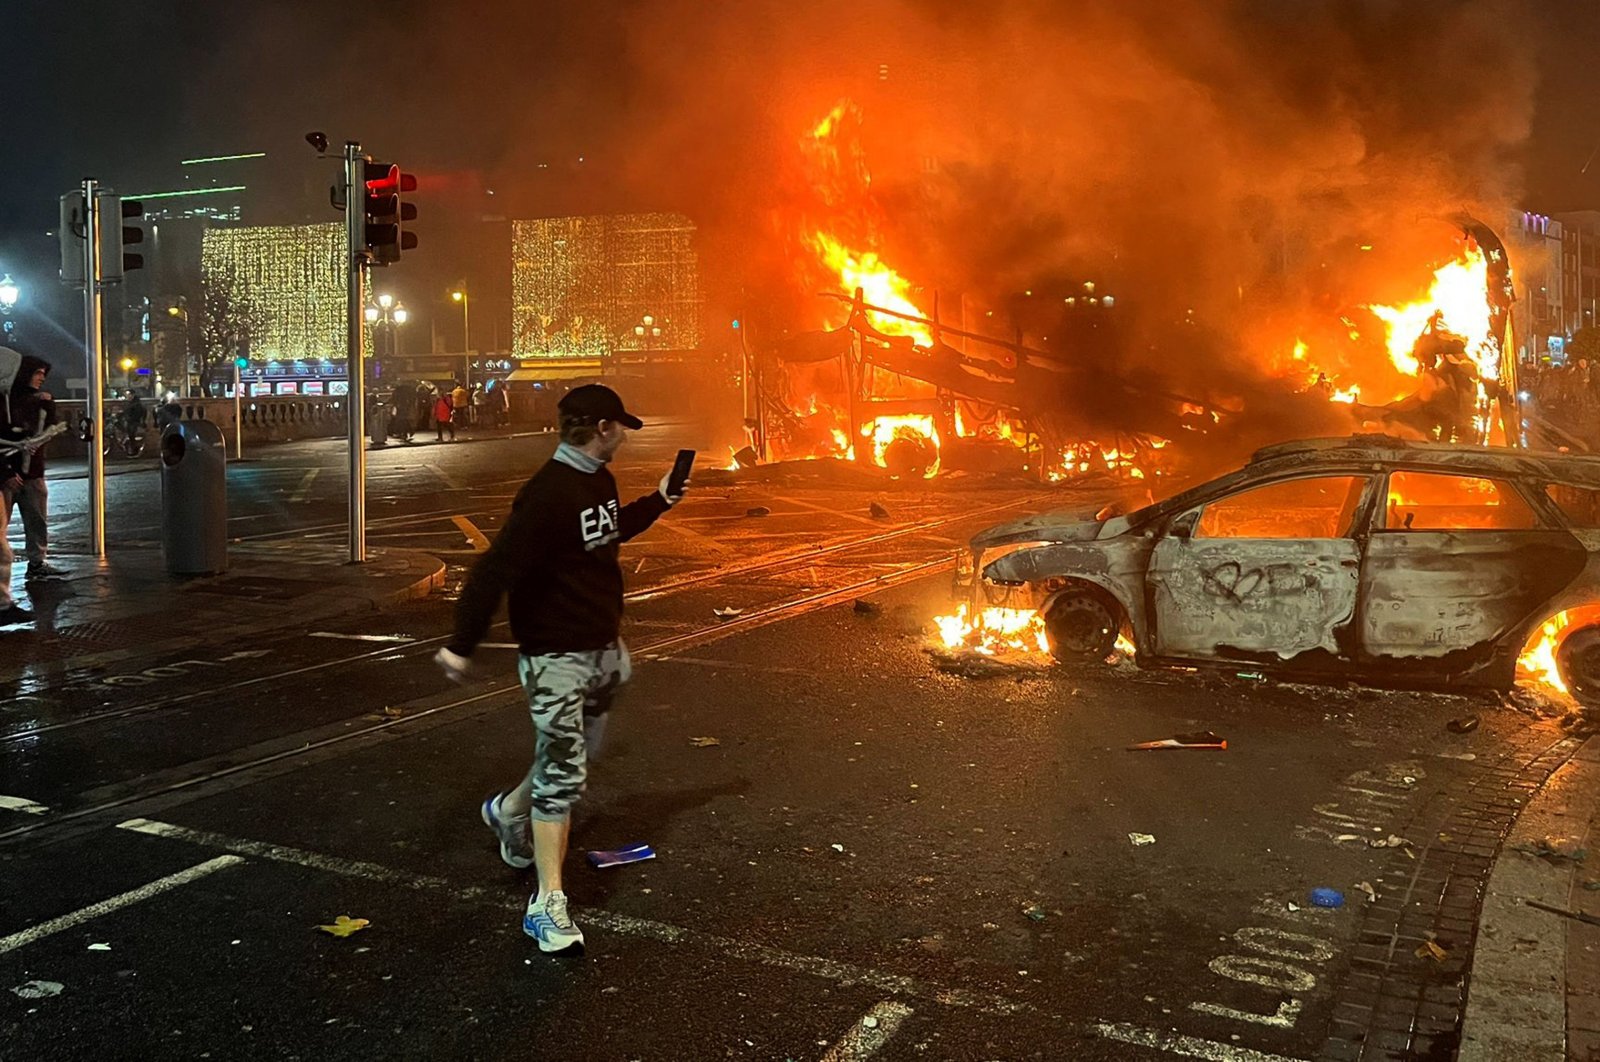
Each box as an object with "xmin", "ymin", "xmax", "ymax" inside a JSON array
[{"xmin": 1146, "ymin": 473, "xmax": 1376, "ymax": 665}]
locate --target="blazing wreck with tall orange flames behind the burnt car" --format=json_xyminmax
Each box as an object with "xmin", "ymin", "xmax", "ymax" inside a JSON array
[{"xmin": 723, "ymin": 87, "xmax": 1520, "ymax": 494}]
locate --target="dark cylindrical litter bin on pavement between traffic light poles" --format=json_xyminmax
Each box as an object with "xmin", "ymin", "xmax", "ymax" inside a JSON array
[{"xmin": 162, "ymin": 421, "xmax": 227, "ymax": 576}]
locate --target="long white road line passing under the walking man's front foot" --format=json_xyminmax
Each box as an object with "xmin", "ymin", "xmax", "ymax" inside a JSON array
[{"xmin": 117, "ymin": 819, "xmax": 1035, "ymax": 1014}]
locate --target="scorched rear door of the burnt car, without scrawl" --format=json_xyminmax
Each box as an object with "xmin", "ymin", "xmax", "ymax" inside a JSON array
[{"xmin": 1358, "ymin": 470, "xmax": 1587, "ymax": 673}]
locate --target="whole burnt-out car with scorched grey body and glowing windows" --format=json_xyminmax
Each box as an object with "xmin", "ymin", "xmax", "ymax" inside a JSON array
[{"xmin": 958, "ymin": 435, "xmax": 1600, "ymax": 701}]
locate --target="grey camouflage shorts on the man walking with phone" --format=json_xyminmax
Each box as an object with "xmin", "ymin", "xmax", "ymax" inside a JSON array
[{"xmin": 517, "ymin": 640, "xmax": 634, "ymax": 822}]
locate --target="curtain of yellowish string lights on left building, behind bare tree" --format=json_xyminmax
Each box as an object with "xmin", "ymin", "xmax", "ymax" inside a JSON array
[{"xmin": 200, "ymin": 222, "xmax": 346, "ymax": 363}]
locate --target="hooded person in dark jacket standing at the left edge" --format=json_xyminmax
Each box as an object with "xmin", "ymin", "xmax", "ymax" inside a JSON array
[{"xmin": 0, "ymin": 347, "xmax": 66, "ymax": 625}]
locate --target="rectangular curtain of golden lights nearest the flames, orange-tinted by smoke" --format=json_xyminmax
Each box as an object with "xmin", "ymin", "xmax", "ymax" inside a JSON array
[{"xmin": 510, "ymin": 214, "xmax": 701, "ymax": 358}]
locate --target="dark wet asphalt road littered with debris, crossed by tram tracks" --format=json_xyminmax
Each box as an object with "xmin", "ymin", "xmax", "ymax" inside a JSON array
[{"xmin": 0, "ymin": 432, "xmax": 1563, "ymax": 1062}]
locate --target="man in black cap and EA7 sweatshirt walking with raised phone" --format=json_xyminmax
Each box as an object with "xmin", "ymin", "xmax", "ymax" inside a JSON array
[{"xmin": 435, "ymin": 384, "xmax": 682, "ymax": 952}]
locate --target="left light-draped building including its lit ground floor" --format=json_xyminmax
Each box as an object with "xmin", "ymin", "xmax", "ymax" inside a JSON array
[{"xmin": 190, "ymin": 222, "xmax": 346, "ymax": 395}]
